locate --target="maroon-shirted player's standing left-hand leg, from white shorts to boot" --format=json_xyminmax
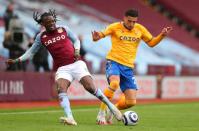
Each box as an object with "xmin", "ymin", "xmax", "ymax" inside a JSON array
[{"xmin": 55, "ymin": 66, "xmax": 77, "ymax": 125}]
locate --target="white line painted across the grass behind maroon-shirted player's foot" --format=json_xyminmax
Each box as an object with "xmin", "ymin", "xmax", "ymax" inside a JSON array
[{"xmin": 0, "ymin": 108, "xmax": 97, "ymax": 115}]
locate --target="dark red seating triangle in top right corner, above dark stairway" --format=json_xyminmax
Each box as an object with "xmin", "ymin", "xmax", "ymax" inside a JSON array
[{"xmin": 157, "ymin": 0, "xmax": 199, "ymax": 30}]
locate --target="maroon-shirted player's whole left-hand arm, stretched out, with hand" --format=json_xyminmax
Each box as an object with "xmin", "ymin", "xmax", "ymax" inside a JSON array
[{"xmin": 6, "ymin": 34, "xmax": 42, "ymax": 65}]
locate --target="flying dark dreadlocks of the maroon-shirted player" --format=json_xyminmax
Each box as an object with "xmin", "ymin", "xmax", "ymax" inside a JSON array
[{"xmin": 33, "ymin": 9, "xmax": 57, "ymax": 24}]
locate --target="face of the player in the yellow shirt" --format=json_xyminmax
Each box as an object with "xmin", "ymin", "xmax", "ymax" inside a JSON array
[{"xmin": 124, "ymin": 16, "xmax": 138, "ymax": 30}]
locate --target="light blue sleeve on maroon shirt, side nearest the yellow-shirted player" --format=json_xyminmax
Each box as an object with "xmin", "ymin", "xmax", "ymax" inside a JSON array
[{"xmin": 64, "ymin": 26, "xmax": 80, "ymax": 50}]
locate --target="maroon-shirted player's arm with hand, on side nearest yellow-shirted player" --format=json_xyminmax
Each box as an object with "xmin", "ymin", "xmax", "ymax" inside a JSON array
[{"xmin": 65, "ymin": 27, "xmax": 80, "ymax": 60}]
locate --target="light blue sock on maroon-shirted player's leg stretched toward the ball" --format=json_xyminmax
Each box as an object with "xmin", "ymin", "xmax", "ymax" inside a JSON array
[{"xmin": 94, "ymin": 88, "xmax": 115, "ymax": 111}]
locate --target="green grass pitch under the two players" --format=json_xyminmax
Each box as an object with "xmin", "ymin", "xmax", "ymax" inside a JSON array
[{"xmin": 0, "ymin": 103, "xmax": 199, "ymax": 131}]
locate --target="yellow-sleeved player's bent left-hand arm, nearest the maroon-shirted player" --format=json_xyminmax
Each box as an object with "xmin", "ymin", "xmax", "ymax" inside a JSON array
[{"xmin": 91, "ymin": 25, "xmax": 113, "ymax": 41}]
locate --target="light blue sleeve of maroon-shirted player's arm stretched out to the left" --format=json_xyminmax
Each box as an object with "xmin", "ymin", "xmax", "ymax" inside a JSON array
[{"xmin": 19, "ymin": 33, "xmax": 42, "ymax": 61}]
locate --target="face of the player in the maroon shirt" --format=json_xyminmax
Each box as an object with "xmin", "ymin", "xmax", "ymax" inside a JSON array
[{"xmin": 42, "ymin": 16, "xmax": 56, "ymax": 31}]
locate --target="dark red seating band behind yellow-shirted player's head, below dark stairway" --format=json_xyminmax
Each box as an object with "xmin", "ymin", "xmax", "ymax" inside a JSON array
[{"xmin": 74, "ymin": 0, "xmax": 199, "ymax": 51}]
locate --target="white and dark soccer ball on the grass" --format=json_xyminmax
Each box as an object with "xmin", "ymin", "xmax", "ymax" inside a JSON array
[{"xmin": 122, "ymin": 111, "xmax": 139, "ymax": 126}]
